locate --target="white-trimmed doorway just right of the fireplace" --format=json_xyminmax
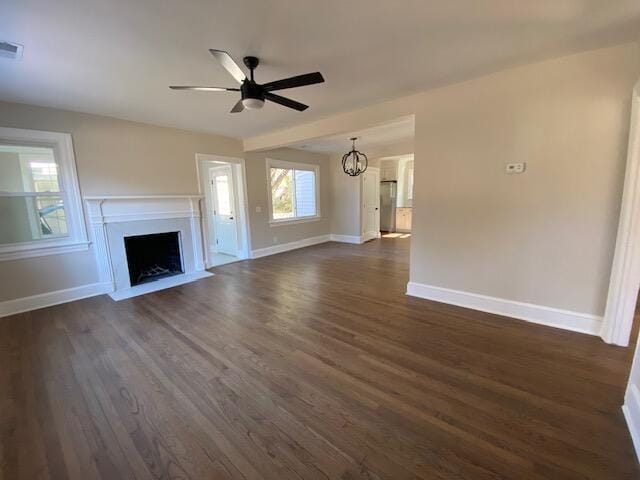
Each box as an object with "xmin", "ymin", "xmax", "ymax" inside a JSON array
[{"xmin": 196, "ymin": 154, "xmax": 250, "ymax": 268}]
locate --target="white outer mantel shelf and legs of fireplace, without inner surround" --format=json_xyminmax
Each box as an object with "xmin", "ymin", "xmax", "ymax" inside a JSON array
[{"xmin": 84, "ymin": 195, "xmax": 204, "ymax": 292}]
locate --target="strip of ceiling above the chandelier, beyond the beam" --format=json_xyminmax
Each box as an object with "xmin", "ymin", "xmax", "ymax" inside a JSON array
[{"xmin": 289, "ymin": 116, "xmax": 415, "ymax": 153}]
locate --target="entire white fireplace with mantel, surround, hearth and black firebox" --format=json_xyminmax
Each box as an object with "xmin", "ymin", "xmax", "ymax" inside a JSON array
[{"xmin": 85, "ymin": 195, "xmax": 213, "ymax": 301}]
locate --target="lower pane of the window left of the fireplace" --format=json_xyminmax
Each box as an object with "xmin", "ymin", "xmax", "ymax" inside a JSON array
[{"xmin": 0, "ymin": 196, "xmax": 68, "ymax": 244}]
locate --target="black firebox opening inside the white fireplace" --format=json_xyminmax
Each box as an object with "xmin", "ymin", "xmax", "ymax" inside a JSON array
[{"xmin": 124, "ymin": 232, "xmax": 184, "ymax": 287}]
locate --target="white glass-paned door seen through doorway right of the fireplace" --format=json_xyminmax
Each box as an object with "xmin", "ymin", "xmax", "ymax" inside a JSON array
[{"xmin": 209, "ymin": 165, "xmax": 238, "ymax": 256}]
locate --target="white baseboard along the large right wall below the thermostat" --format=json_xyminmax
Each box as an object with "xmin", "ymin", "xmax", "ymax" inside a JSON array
[{"xmin": 407, "ymin": 282, "xmax": 602, "ymax": 335}]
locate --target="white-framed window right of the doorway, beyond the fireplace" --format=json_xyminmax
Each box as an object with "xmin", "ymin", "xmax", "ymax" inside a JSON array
[{"xmin": 267, "ymin": 159, "xmax": 320, "ymax": 223}]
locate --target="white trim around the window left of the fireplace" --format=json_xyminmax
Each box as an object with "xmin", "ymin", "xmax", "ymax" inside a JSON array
[{"xmin": 0, "ymin": 127, "xmax": 89, "ymax": 261}]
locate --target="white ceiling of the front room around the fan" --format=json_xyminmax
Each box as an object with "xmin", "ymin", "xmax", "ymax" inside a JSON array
[{"xmin": 0, "ymin": 0, "xmax": 640, "ymax": 137}]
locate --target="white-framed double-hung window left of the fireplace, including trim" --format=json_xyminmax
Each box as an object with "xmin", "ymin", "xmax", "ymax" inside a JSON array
[{"xmin": 0, "ymin": 128, "xmax": 88, "ymax": 260}]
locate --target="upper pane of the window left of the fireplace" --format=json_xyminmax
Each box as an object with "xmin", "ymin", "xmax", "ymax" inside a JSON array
[{"xmin": 0, "ymin": 145, "xmax": 60, "ymax": 193}]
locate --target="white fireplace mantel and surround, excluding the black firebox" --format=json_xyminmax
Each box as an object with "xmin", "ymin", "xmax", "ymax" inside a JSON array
[{"xmin": 84, "ymin": 195, "xmax": 206, "ymax": 299}]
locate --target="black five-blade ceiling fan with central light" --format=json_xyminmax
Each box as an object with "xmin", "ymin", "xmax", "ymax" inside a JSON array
[{"xmin": 169, "ymin": 49, "xmax": 324, "ymax": 113}]
